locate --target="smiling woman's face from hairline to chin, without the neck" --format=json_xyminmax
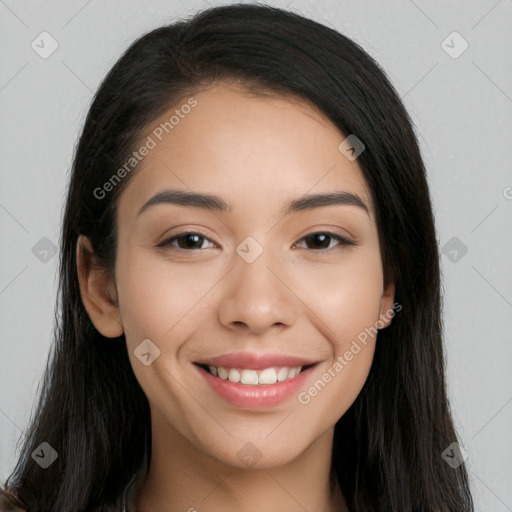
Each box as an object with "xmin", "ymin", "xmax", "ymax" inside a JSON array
[{"xmin": 84, "ymin": 84, "xmax": 393, "ymax": 467}]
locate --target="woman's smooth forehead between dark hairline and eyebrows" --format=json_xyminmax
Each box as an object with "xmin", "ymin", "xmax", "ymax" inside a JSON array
[{"xmin": 119, "ymin": 83, "xmax": 371, "ymax": 218}]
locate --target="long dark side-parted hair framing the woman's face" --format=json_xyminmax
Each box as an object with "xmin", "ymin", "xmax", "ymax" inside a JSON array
[{"xmin": 7, "ymin": 4, "xmax": 473, "ymax": 512}]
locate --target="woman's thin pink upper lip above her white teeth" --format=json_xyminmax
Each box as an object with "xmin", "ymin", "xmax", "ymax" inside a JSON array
[{"xmin": 196, "ymin": 352, "xmax": 317, "ymax": 370}]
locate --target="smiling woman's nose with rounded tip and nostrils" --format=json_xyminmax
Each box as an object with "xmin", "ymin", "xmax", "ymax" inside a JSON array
[{"xmin": 218, "ymin": 250, "xmax": 300, "ymax": 334}]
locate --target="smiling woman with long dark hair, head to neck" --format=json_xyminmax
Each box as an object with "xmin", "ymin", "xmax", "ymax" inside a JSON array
[{"xmin": 2, "ymin": 5, "xmax": 473, "ymax": 512}]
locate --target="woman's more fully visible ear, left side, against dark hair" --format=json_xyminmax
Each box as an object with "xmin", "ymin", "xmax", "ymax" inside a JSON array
[{"xmin": 76, "ymin": 235, "xmax": 124, "ymax": 338}]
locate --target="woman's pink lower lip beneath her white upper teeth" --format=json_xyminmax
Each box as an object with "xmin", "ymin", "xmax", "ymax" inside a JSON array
[{"xmin": 194, "ymin": 364, "xmax": 316, "ymax": 409}]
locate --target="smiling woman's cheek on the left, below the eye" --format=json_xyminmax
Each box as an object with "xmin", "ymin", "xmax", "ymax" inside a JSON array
[{"xmin": 116, "ymin": 248, "xmax": 218, "ymax": 416}]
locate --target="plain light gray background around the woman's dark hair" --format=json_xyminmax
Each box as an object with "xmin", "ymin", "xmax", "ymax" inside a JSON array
[{"xmin": 0, "ymin": 0, "xmax": 512, "ymax": 512}]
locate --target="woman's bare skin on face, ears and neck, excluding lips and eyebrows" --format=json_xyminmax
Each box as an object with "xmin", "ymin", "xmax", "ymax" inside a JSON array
[{"xmin": 77, "ymin": 83, "xmax": 394, "ymax": 512}]
